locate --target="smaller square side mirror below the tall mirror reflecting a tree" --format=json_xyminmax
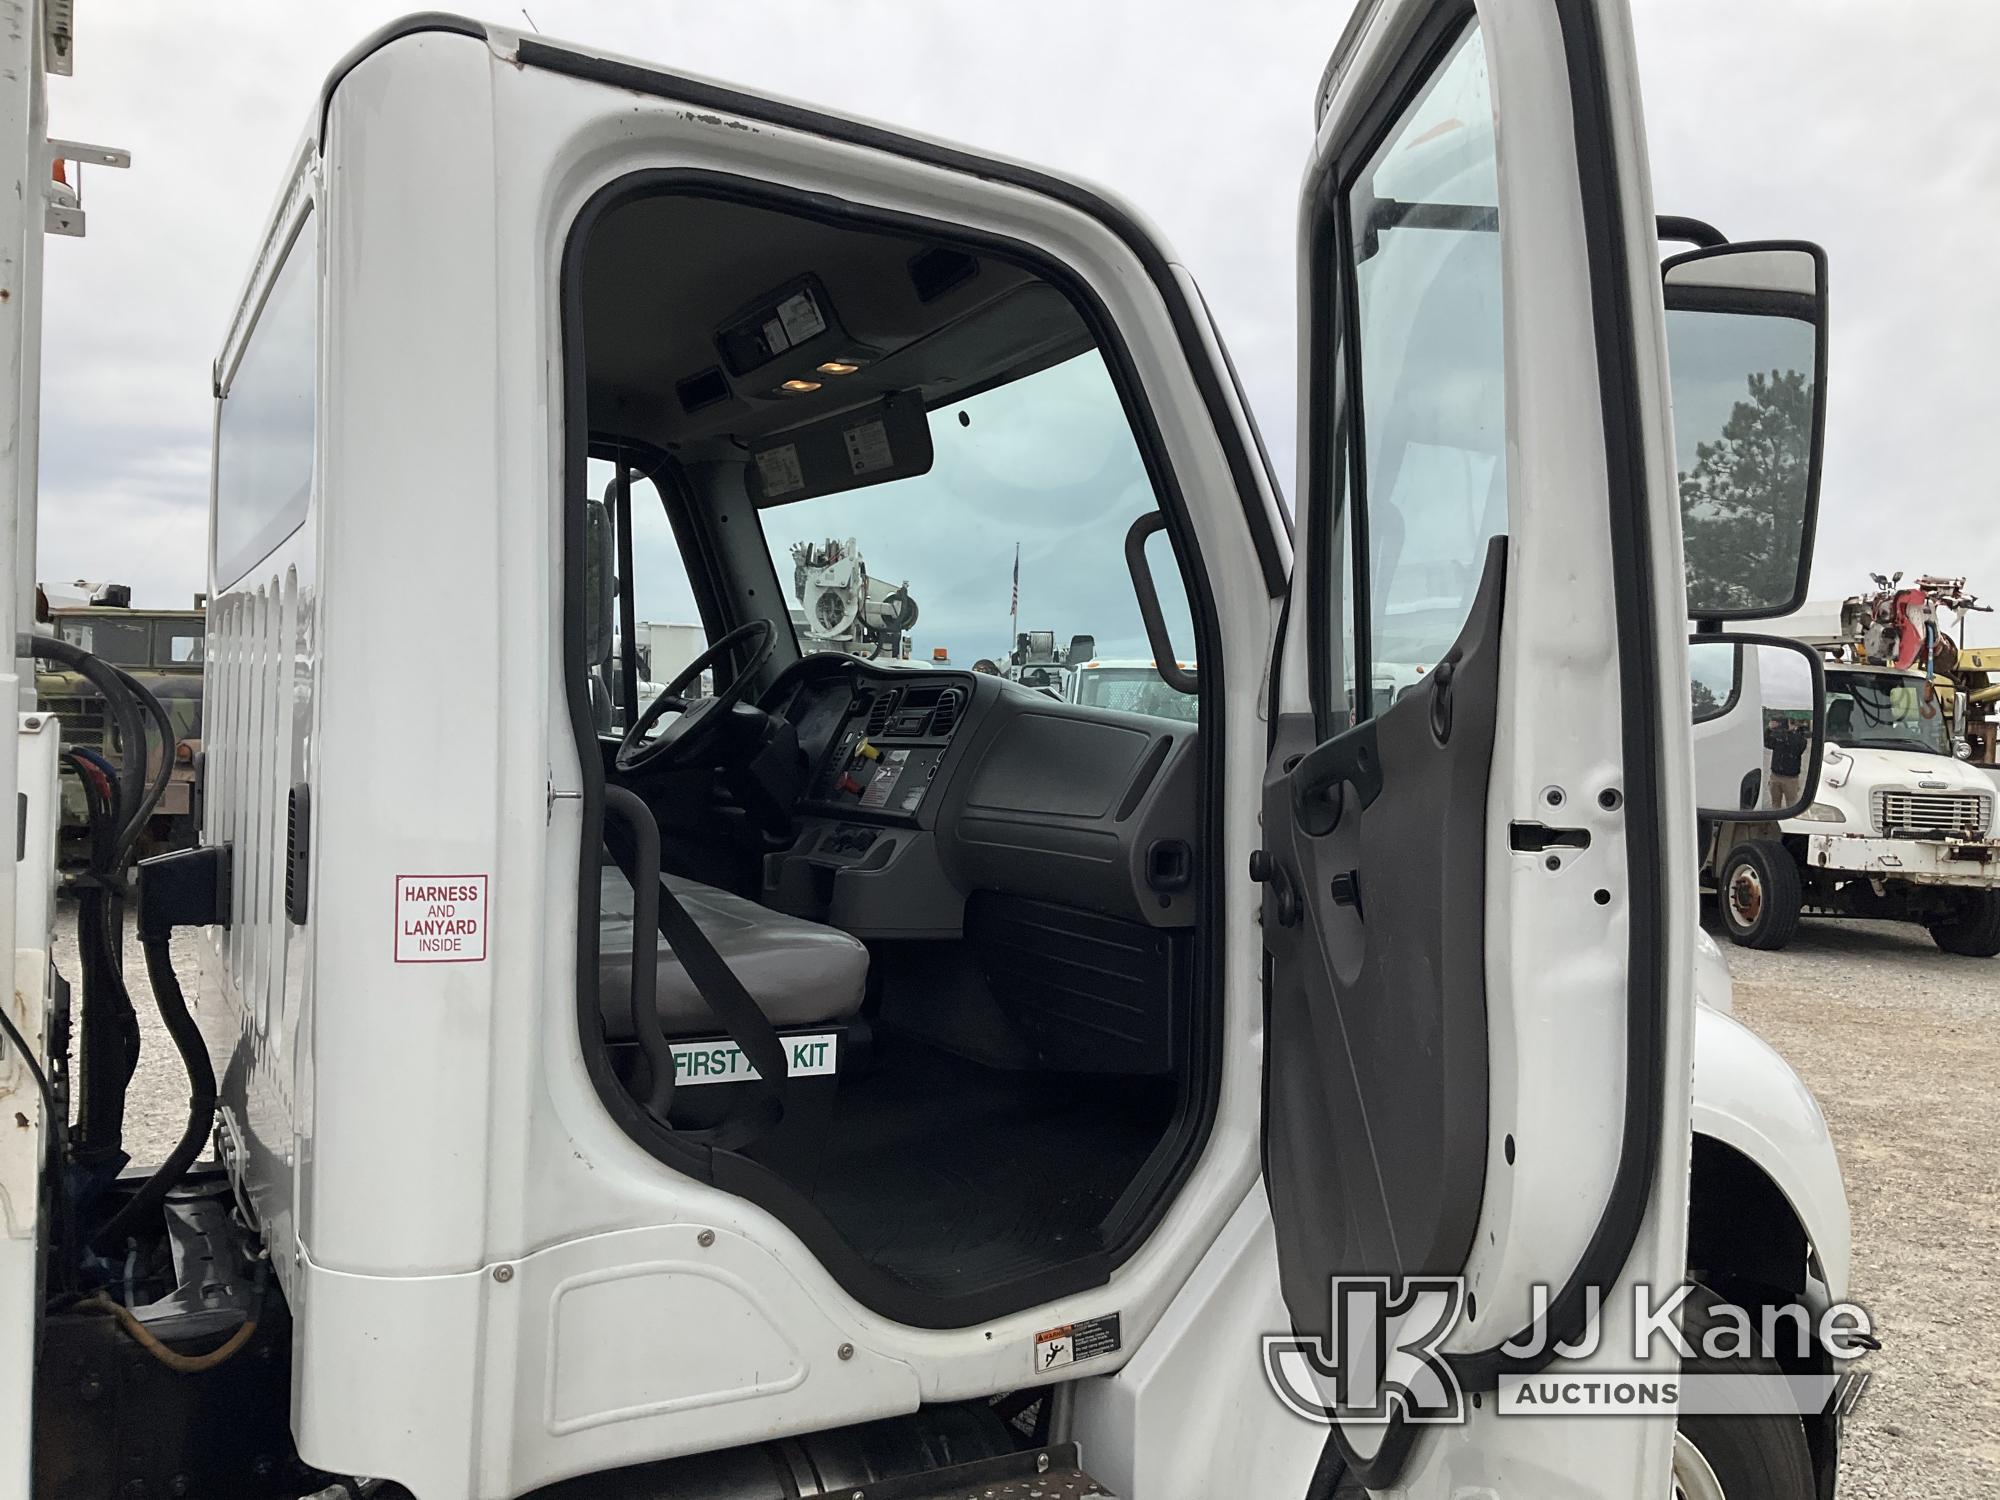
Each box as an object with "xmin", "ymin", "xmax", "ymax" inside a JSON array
[{"xmin": 1688, "ymin": 636, "xmax": 1826, "ymax": 822}]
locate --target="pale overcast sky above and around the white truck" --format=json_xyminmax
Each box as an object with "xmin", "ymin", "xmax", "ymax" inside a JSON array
[{"xmin": 40, "ymin": 0, "xmax": 2000, "ymax": 640}]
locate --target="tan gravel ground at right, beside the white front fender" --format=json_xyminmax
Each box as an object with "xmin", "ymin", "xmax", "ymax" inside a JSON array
[{"xmin": 1710, "ymin": 904, "xmax": 2000, "ymax": 1500}]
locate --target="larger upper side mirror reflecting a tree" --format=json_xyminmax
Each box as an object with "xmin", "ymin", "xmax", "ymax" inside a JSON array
[{"xmin": 1660, "ymin": 240, "xmax": 1826, "ymax": 620}]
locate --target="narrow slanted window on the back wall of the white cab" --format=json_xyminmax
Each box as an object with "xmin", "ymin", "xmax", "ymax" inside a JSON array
[{"xmin": 214, "ymin": 218, "xmax": 320, "ymax": 588}]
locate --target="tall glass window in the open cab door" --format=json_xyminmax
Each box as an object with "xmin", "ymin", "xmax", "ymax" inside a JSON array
[{"xmin": 1320, "ymin": 28, "xmax": 1508, "ymax": 716}]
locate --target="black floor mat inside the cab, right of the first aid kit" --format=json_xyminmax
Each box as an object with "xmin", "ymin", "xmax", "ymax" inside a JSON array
[{"xmin": 814, "ymin": 1038, "xmax": 1172, "ymax": 1296}]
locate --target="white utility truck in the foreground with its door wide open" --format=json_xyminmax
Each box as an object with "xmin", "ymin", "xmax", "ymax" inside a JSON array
[{"xmin": 0, "ymin": 0, "xmax": 1862, "ymax": 1500}]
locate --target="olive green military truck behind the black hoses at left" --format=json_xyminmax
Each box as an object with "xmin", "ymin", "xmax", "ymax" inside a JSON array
[{"xmin": 34, "ymin": 588, "xmax": 208, "ymax": 862}]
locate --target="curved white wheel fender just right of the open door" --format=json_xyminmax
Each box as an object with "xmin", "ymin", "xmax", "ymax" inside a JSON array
[{"xmin": 1694, "ymin": 1006, "xmax": 1852, "ymax": 1302}]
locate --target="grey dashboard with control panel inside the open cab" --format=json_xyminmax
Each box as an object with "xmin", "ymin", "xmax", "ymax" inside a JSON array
[{"xmin": 762, "ymin": 652, "xmax": 1200, "ymax": 938}]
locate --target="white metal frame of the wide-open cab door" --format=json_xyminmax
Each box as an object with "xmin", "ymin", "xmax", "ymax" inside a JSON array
[{"xmin": 1282, "ymin": 0, "xmax": 1698, "ymax": 1496}]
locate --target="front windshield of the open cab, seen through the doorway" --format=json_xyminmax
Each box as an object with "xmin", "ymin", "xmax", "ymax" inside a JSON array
[{"xmin": 758, "ymin": 350, "xmax": 1194, "ymax": 668}]
